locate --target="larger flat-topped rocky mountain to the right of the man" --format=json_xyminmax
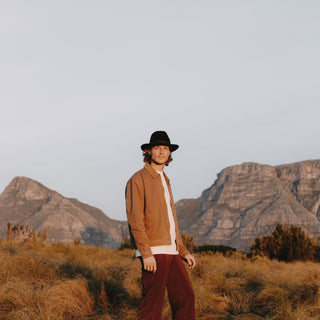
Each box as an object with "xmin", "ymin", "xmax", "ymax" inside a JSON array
[{"xmin": 176, "ymin": 160, "xmax": 320, "ymax": 250}]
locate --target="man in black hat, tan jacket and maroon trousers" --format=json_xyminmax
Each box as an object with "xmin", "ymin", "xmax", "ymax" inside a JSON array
[{"xmin": 126, "ymin": 131, "xmax": 196, "ymax": 320}]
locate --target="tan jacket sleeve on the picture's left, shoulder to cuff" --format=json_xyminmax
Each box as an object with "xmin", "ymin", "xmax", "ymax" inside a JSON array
[{"xmin": 126, "ymin": 177, "xmax": 152, "ymax": 259}]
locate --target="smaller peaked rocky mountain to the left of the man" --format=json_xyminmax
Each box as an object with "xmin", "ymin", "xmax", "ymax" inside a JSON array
[{"xmin": 0, "ymin": 177, "xmax": 128, "ymax": 248}]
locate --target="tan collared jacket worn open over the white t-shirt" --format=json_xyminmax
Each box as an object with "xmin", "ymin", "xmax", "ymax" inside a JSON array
[{"xmin": 126, "ymin": 163, "xmax": 189, "ymax": 258}]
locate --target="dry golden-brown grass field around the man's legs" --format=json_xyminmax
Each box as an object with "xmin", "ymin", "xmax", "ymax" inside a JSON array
[{"xmin": 0, "ymin": 240, "xmax": 320, "ymax": 320}]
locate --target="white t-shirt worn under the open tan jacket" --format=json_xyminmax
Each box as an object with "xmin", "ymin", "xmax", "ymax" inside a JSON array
[{"xmin": 136, "ymin": 171, "xmax": 179, "ymax": 257}]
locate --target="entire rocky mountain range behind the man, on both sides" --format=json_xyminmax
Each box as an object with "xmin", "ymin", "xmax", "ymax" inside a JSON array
[{"xmin": 0, "ymin": 160, "xmax": 320, "ymax": 250}]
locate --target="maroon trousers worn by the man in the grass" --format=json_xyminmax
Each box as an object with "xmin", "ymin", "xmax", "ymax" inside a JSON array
[{"xmin": 139, "ymin": 254, "xmax": 194, "ymax": 320}]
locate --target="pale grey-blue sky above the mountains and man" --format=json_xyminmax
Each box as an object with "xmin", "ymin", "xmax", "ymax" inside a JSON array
[{"xmin": 0, "ymin": 0, "xmax": 320, "ymax": 220}]
